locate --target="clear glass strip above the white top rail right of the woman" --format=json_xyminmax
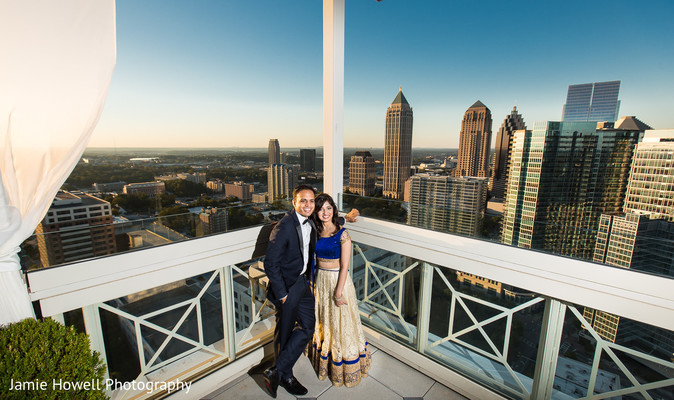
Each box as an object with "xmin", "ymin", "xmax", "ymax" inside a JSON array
[{"xmin": 342, "ymin": 192, "xmax": 674, "ymax": 278}]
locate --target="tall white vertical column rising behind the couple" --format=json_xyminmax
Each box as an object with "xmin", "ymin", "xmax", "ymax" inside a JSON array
[{"xmin": 323, "ymin": 0, "xmax": 344, "ymax": 202}]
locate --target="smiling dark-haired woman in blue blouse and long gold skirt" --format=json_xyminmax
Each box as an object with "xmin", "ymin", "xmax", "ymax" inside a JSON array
[{"xmin": 308, "ymin": 194, "xmax": 372, "ymax": 387}]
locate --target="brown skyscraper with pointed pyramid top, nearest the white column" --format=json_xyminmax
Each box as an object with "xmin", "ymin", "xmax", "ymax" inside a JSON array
[{"xmin": 383, "ymin": 87, "xmax": 412, "ymax": 199}]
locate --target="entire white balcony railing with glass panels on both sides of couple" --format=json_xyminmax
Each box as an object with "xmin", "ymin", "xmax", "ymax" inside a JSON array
[{"xmin": 28, "ymin": 218, "xmax": 674, "ymax": 399}]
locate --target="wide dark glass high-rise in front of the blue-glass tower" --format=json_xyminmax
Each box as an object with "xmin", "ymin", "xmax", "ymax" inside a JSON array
[{"xmin": 501, "ymin": 121, "xmax": 642, "ymax": 259}]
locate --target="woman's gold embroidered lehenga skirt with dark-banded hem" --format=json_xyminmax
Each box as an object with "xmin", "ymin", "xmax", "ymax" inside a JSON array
[{"xmin": 307, "ymin": 268, "xmax": 372, "ymax": 387}]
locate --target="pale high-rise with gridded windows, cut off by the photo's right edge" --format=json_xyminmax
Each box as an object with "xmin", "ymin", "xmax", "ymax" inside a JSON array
[{"xmin": 583, "ymin": 129, "xmax": 674, "ymax": 355}]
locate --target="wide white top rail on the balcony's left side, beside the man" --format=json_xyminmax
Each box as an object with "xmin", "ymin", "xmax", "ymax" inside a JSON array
[{"xmin": 27, "ymin": 226, "xmax": 262, "ymax": 316}]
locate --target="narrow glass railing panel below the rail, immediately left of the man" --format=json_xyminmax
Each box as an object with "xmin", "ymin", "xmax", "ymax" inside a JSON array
[{"xmin": 232, "ymin": 258, "xmax": 276, "ymax": 353}]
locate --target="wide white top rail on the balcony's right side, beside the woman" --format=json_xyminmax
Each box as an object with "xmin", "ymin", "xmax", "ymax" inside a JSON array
[{"xmin": 348, "ymin": 217, "xmax": 674, "ymax": 331}]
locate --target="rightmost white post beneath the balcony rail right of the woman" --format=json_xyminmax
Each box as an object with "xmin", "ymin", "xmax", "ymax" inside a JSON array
[{"xmin": 531, "ymin": 298, "xmax": 566, "ymax": 400}]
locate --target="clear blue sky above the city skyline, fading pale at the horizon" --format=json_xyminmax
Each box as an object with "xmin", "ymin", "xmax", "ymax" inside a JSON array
[{"xmin": 89, "ymin": 0, "xmax": 674, "ymax": 149}]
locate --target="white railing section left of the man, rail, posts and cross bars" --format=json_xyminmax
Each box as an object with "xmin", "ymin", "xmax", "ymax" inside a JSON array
[{"xmin": 27, "ymin": 227, "xmax": 273, "ymax": 399}]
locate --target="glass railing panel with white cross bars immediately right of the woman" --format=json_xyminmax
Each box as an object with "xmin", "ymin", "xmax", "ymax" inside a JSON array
[{"xmin": 352, "ymin": 243, "xmax": 420, "ymax": 346}]
